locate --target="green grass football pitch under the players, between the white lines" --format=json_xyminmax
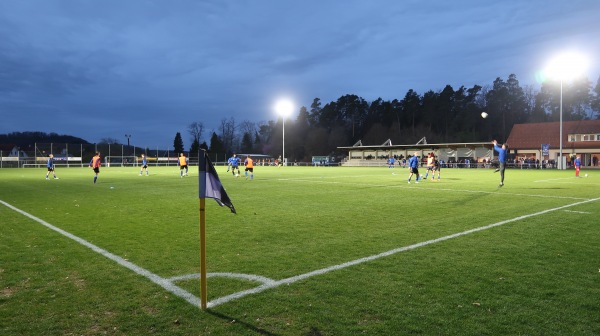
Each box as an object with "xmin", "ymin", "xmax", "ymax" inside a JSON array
[{"xmin": 0, "ymin": 167, "xmax": 600, "ymax": 335}]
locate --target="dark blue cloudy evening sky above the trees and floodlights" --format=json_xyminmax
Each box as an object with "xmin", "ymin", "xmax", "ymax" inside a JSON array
[{"xmin": 0, "ymin": 0, "xmax": 600, "ymax": 148}]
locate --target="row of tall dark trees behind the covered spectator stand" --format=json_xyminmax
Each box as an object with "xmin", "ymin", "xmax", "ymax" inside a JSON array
[{"xmin": 174, "ymin": 74, "xmax": 600, "ymax": 161}]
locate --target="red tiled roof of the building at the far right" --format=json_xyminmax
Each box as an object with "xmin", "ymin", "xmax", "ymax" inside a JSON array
[{"xmin": 506, "ymin": 120, "xmax": 600, "ymax": 149}]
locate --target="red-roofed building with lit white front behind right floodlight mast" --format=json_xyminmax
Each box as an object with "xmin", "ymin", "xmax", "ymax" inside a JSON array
[{"xmin": 506, "ymin": 120, "xmax": 600, "ymax": 167}]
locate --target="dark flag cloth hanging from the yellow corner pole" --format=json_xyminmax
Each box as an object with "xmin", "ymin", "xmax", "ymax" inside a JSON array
[{"xmin": 198, "ymin": 150, "xmax": 236, "ymax": 213}]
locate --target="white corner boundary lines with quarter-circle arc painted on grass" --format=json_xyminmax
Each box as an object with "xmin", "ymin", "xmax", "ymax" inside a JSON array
[{"xmin": 0, "ymin": 198, "xmax": 600, "ymax": 308}]
